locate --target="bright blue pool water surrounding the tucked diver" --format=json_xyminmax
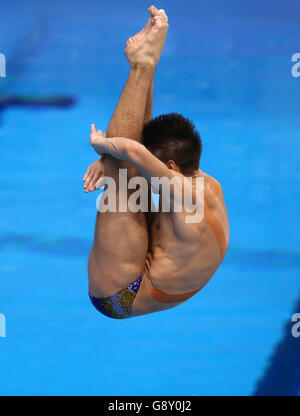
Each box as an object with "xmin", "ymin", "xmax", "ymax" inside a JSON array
[{"xmin": 0, "ymin": 0, "xmax": 300, "ymax": 395}]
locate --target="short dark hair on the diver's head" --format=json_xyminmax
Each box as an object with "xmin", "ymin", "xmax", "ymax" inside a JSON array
[{"xmin": 142, "ymin": 113, "xmax": 202, "ymax": 175}]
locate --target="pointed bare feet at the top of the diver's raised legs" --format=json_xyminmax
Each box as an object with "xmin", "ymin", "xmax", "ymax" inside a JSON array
[{"xmin": 125, "ymin": 6, "xmax": 169, "ymax": 67}]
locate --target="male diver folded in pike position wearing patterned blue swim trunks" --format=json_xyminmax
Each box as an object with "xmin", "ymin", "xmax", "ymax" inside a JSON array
[{"xmin": 84, "ymin": 6, "xmax": 229, "ymax": 319}]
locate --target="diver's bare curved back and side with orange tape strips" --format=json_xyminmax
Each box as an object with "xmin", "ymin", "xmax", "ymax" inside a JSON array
[{"xmin": 134, "ymin": 171, "xmax": 229, "ymax": 313}]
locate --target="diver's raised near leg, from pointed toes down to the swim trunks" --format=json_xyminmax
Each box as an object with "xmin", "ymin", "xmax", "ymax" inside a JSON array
[{"xmin": 89, "ymin": 9, "xmax": 167, "ymax": 297}]
